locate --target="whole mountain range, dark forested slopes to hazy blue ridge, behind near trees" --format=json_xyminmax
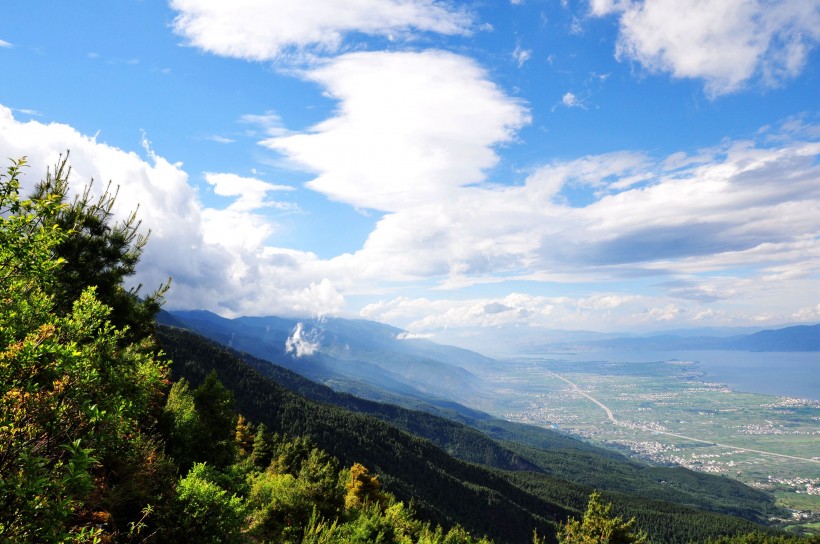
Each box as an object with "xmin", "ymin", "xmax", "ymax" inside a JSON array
[{"xmin": 151, "ymin": 311, "xmax": 804, "ymax": 542}]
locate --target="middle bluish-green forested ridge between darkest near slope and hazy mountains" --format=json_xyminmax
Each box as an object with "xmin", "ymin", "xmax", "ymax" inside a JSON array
[{"xmin": 231, "ymin": 344, "xmax": 772, "ymax": 520}]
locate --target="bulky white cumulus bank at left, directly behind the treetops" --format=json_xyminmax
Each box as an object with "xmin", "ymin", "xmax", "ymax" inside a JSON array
[{"xmin": 0, "ymin": 106, "xmax": 344, "ymax": 315}]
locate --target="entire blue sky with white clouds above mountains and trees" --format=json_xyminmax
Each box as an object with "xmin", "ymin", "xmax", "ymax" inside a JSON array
[{"xmin": 0, "ymin": 0, "xmax": 820, "ymax": 337}]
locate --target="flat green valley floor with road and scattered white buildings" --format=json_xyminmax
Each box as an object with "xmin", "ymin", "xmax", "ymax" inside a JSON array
[{"xmin": 484, "ymin": 358, "xmax": 820, "ymax": 524}]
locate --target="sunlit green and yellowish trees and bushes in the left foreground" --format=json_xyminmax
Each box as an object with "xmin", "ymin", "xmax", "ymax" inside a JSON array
[{"xmin": 0, "ymin": 155, "xmax": 500, "ymax": 543}]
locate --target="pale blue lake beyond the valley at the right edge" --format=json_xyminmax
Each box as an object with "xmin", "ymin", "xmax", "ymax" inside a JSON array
[{"xmin": 545, "ymin": 350, "xmax": 820, "ymax": 401}]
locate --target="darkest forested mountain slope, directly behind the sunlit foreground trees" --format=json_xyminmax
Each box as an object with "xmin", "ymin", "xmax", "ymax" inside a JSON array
[{"xmin": 159, "ymin": 327, "xmax": 772, "ymax": 542}]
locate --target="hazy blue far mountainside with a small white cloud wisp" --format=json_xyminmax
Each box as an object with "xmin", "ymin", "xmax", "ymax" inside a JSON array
[{"xmin": 163, "ymin": 311, "xmax": 492, "ymax": 405}]
